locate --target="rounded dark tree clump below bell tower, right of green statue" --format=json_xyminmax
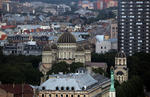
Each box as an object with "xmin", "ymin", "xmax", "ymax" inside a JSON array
[{"xmin": 116, "ymin": 76, "xmax": 144, "ymax": 97}]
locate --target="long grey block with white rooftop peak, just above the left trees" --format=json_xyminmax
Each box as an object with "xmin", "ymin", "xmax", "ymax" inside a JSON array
[{"xmin": 3, "ymin": 41, "xmax": 43, "ymax": 56}]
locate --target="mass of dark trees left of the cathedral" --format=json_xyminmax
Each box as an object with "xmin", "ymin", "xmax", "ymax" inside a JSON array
[{"xmin": 0, "ymin": 52, "xmax": 42, "ymax": 85}]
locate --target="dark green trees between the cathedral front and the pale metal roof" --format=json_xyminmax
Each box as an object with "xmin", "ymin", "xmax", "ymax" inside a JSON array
[{"xmin": 47, "ymin": 61, "xmax": 83, "ymax": 75}]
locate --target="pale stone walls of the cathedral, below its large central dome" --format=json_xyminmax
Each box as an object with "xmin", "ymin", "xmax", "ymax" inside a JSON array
[{"xmin": 40, "ymin": 43, "xmax": 91, "ymax": 72}]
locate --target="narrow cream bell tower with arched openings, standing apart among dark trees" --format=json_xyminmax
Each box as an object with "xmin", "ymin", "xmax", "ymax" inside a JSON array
[{"xmin": 114, "ymin": 52, "xmax": 128, "ymax": 83}]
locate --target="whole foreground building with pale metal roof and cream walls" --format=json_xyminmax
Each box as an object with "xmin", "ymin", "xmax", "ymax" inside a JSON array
[{"xmin": 38, "ymin": 71, "xmax": 110, "ymax": 97}]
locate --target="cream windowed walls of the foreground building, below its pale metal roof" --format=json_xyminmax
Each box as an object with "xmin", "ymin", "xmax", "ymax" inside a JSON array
[{"xmin": 38, "ymin": 83, "xmax": 110, "ymax": 97}]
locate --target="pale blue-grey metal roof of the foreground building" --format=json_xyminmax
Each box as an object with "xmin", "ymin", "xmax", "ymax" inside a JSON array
[{"xmin": 39, "ymin": 73, "xmax": 98, "ymax": 90}]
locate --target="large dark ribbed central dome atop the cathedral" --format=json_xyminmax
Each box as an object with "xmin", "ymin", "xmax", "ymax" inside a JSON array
[{"xmin": 57, "ymin": 32, "xmax": 76, "ymax": 43}]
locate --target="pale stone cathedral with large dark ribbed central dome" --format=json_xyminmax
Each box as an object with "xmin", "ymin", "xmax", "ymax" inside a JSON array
[{"xmin": 39, "ymin": 32, "xmax": 91, "ymax": 74}]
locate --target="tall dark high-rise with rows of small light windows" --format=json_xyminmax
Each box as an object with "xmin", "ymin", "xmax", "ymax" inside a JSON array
[{"xmin": 118, "ymin": 0, "xmax": 150, "ymax": 56}]
